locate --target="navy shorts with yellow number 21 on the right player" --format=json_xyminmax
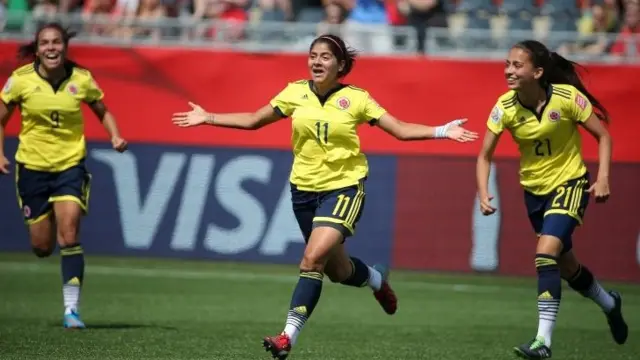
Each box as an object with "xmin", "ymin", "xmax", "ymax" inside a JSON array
[{"xmin": 524, "ymin": 173, "xmax": 589, "ymax": 253}]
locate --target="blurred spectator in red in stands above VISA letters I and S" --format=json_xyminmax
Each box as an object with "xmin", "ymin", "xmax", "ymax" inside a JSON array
[{"xmin": 193, "ymin": 0, "xmax": 249, "ymax": 41}]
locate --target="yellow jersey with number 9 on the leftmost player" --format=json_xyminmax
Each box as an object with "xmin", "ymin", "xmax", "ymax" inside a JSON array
[{"xmin": 0, "ymin": 63, "xmax": 104, "ymax": 172}]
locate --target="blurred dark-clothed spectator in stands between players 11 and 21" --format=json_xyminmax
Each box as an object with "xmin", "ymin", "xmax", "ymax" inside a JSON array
[{"xmin": 398, "ymin": 0, "xmax": 448, "ymax": 52}]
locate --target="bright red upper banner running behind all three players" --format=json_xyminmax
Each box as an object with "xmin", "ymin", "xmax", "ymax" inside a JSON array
[{"xmin": 0, "ymin": 43, "xmax": 640, "ymax": 162}]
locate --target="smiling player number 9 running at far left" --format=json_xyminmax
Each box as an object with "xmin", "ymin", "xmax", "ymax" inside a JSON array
[{"xmin": 0, "ymin": 23, "xmax": 127, "ymax": 329}]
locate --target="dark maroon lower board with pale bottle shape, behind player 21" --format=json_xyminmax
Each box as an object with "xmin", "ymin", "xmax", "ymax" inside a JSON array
[{"xmin": 393, "ymin": 156, "xmax": 640, "ymax": 281}]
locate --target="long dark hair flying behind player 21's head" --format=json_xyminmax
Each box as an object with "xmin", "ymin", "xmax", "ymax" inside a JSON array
[{"xmin": 513, "ymin": 40, "xmax": 610, "ymax": 123}]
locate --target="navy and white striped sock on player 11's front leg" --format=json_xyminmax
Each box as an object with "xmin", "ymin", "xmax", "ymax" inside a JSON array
[{"xmin": 284, "ymin": 271, "xmax": 324, "ymax": 345}]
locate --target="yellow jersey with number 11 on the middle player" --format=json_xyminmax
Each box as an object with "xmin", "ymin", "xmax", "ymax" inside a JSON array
[{"xmin": 270, "ymin": 80, "xmax": 386, "ymax": 191}]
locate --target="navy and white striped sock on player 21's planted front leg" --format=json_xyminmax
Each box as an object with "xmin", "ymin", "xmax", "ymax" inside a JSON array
[{"xmin": 536, "ymin": 254, "xmax": 562, "ymax": 347}]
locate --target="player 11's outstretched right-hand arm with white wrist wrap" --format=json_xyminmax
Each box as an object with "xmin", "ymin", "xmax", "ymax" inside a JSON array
[{"xmin": 377, "ymin": 113, "xmax": 478, "ymax": 142}]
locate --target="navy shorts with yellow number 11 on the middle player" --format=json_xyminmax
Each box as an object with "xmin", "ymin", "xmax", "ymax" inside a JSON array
[{"xmin": 291, "ymin": 179, "xmax": 365, "ymax": 242}]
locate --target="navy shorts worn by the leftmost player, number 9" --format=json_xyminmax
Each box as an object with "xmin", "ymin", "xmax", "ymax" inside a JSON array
[{"xmin": 16, "ymin": 162, "xmax": 91, "ymax": 224}]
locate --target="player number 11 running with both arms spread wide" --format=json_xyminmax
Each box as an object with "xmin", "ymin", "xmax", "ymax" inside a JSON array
[{"xmin": 173, "ymin": 35, "xmax": 478, "ymax": 359}]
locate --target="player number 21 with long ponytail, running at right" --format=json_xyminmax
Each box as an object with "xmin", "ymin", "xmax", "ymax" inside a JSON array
[{"xmin": 476, "ymin": 40, "xmax": 628, "ymax": 359}]
